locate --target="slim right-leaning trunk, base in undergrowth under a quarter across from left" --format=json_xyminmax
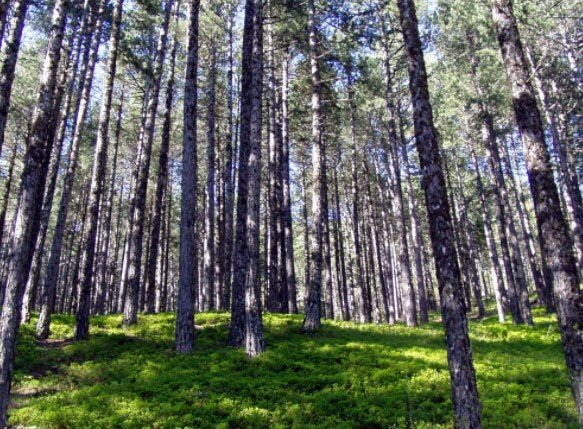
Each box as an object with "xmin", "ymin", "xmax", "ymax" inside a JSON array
[{"xmin": 123, "ymin": 0, "xmax": 174, "ymax": 326}]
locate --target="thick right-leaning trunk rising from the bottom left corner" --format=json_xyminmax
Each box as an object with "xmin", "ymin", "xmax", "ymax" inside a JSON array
[{"xmin": 0, "ymin": 0, "xmax": 68, "ymax": 427}]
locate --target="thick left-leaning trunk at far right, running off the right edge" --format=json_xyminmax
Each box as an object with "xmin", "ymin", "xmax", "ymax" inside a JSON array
[{"xmin": 492, "ymin": 0, "xmax": 583, "ymax": 425}]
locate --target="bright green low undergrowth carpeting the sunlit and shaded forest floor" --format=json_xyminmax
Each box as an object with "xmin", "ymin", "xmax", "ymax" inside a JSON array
[{"xmin": 10, "ymin": 310, "xmax": 578, "ymax": 428}]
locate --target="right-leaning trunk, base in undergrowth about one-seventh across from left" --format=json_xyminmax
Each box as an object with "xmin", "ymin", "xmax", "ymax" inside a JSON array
[{"xmin": 74, "ymin": 0, "xmax": 123, "ymax": 340}]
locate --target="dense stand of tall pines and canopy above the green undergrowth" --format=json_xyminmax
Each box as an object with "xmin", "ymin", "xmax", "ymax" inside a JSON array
[{"xmin": 0, "ymin": 0, "xmax": 583, "ymax": 427}]
